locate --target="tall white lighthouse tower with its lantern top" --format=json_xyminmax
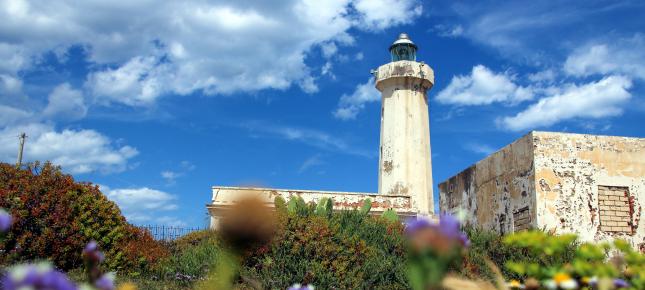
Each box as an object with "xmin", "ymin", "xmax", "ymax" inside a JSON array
[{"xmin": 374, "ymin": 33, "xmax": 434, "ymax": 216}]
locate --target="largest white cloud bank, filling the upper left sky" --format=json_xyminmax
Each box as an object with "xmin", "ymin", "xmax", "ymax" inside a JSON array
[{"xmin": 0, "ymin": 0, "xmax": 422, "ymax": 106}]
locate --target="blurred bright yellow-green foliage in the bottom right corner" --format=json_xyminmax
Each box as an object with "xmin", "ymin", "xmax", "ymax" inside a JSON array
[{"xmin": 504, "ymin": 231, "xmax": 645, "ymax": 289}]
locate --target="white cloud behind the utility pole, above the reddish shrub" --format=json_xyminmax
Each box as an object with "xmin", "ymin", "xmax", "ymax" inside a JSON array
[{"xmin": 0, "ymin": 123, "xmax": 138, "ymax": 173}]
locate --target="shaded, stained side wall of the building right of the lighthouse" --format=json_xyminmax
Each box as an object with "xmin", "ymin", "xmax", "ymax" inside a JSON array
[{"xmin": 439, "ymin": 134, "xmax": 536, "ymax": 233}]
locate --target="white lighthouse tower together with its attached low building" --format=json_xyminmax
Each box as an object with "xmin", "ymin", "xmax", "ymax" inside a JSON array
[{"xmin": 206, "ymin": 33, "xmax": 434, "ymax": 228}]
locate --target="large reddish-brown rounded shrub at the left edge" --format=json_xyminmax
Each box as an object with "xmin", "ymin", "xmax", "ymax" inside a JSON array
[{"xmin": 0, "ymin": 163, "xmax": 165, "ymax": 271}]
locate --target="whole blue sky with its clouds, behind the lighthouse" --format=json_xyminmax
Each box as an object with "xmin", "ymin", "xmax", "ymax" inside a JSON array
[{"xmin": 0, "ymin": 0, "xmax": 645, "ymax": 226}]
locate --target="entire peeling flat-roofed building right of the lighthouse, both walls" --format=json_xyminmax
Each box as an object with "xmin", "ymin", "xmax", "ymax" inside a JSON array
[{"xmin": 439, "ymin": 132, "xmax": 645, "ymax": 247}]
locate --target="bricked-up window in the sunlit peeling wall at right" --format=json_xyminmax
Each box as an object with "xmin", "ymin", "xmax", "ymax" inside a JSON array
[{"xmin": 598, "ymin": 186, "xmax": 632, "ymax": 234}]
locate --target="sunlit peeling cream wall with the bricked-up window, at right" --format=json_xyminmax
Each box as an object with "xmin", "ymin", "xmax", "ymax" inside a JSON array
[{"xmin": 532, "ymin": 132, "xmax": 645, "ymax": 246}]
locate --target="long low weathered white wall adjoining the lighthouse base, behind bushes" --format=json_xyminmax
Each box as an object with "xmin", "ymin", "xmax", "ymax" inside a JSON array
[{"xmin": 206, "ymin": 186, "xmax": 415, "ymax": 228}]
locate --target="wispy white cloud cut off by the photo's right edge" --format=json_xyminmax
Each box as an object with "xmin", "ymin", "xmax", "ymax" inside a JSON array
[{"xmin": 564, "ymin": 34, "xmax": 645, "ymax": 79}]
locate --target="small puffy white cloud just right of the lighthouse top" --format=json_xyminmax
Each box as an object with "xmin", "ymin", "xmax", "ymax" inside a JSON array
[{"xmin": 435, "ymin": 65, "xmax": 534, "ymax": 106}]
